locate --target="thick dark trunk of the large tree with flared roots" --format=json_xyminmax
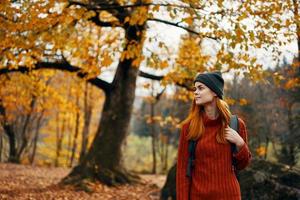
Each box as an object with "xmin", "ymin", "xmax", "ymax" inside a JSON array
[{"xmin": 62, "ymin": 22, "xmax": 144, "ymax": 189}]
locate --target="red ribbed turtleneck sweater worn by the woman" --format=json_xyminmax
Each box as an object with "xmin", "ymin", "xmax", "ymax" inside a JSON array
[{"xmin": 176, "ymin": 114, "xmax": 251, "ymax": 200}]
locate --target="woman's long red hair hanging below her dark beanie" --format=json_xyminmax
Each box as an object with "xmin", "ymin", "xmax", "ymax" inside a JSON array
[{"xmin": 181, "ymin": 97, "xmax": 231, "ymax": 144}]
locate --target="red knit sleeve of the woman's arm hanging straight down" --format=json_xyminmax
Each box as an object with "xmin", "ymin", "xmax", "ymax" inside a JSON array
[{"xmin": 176, "ymin": 124, "xmax": 189, "ymax": 200}]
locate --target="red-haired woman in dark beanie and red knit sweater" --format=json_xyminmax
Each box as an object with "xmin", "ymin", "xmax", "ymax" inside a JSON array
[{"xmin": 176, "ymin": 72, "xmax": 251, "ymax": 200}]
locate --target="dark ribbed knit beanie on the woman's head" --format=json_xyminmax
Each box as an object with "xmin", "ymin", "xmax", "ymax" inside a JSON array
[{"xmin": 194, "ymin": 71, "xmax": 224, "ymax": 99}]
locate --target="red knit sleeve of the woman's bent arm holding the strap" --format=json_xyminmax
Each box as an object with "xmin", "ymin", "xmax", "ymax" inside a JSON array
[{"xmin": 233, "ymin": 118, "xmax": 252, "ymax": 170}]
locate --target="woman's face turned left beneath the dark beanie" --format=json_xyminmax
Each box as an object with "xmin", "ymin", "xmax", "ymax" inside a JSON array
[{"xmin": 194, "ymin": 82, "xmax": 217, "ymax": 105}]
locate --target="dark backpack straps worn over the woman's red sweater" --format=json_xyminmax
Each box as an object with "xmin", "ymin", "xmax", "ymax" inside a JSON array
[{"xmin": 186, "ymin": 115, "xmax": 239, "ymax": 178}]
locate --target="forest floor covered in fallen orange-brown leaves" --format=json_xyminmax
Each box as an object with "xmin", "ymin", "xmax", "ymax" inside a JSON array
[{"xmin": 0, "ymin": 163, "xmax": 166, "ymax": 200}]
